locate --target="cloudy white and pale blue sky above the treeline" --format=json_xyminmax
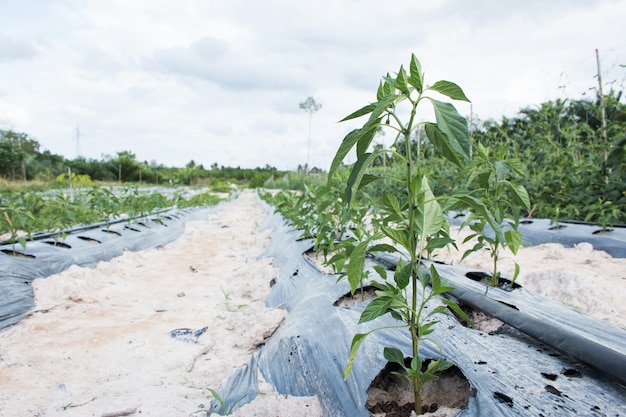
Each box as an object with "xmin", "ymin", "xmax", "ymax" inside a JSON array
[{"xmin": 0, "ymin": 0, "xmax": 626, "ymax": 169}]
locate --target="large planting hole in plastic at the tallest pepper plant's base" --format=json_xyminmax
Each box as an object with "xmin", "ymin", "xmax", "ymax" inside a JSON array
[{"xmin": 365, "ymin": 358, "xmax": 472, "ymax": 416}]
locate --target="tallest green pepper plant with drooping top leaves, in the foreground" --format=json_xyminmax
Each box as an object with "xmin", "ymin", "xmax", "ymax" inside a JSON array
[{"xmin": 328, "ymin": 55, "xmax": 470, "ymax": 414}]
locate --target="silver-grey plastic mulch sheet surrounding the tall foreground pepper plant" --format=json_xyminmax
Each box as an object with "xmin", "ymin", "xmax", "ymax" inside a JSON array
[{"xmin": 202, "ymin": 196, "xmax": 626, "ymax": 417}]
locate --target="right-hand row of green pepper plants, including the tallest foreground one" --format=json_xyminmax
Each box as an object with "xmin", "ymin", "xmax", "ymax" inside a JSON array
[{"xmin": 258, "ymin": 55, "xmax": 620, "ymax": 414}]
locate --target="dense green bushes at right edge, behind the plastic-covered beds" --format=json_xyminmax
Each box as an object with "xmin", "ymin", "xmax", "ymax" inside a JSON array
[{"xmin": 474, "ymin": 90, "xmax": 626, "ymax": 226}]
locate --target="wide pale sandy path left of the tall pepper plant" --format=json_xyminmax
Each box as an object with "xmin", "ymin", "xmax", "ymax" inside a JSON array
[{"xmin": 0, "ymin": 191, "xmax": 320, "ymax": 417}]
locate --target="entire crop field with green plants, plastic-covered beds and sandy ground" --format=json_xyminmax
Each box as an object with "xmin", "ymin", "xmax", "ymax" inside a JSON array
[{"xmin": 0, "ymin": 56, "xmax": 626, "ymax": 417}]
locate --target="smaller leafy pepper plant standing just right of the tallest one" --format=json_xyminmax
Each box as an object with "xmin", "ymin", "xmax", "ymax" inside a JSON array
[{"xmin": 456, "ymin": 143, "xmax": 530, "ymax": 287}]
